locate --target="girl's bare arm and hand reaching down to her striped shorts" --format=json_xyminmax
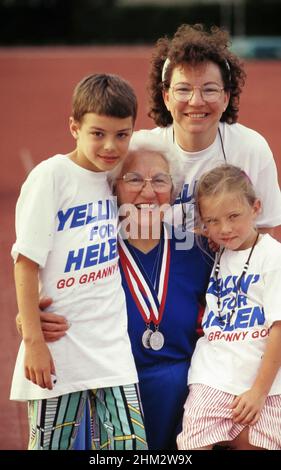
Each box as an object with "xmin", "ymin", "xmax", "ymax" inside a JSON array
[{"xmin": 231, "ymin": 321, "xmax": 281, "ymax": 425}]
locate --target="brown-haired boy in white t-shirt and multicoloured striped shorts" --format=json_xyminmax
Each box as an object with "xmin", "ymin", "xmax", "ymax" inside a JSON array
[{"xmin": 11, "ymin": 74, "xmax": 146, "ymax": 450}]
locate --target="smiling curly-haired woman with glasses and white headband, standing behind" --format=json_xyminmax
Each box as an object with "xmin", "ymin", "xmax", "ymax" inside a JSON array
[{"xmin": 145, "ymin": 24, "xmax": 281, "ymax": 233}]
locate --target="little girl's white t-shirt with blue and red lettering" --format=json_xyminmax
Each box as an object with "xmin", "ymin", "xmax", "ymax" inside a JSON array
[{"xmin": 188, "ymin": 234, "xmax": 281, "ymax": 395}]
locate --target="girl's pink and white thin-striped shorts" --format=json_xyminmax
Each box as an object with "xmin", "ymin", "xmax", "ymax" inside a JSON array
[{"xmin": 177, "ymin": 384, "xmax": 281, "ymax": 450}]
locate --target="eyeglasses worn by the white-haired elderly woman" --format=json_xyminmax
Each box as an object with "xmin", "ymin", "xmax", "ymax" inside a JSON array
[{"xmin": 117, "ymin": 173, "xmax": 173, "ymax": 193}]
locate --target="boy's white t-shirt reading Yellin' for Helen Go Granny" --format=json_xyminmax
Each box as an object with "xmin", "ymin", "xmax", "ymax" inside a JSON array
[{"xmin": 11, "ymin": 155, "xmax": 138, "ymax": 400}]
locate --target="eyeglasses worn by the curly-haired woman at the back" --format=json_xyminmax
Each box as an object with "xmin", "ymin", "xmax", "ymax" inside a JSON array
[{"xmin": 170, "ymin": 83, "xmax": 224, "ymax": 103}]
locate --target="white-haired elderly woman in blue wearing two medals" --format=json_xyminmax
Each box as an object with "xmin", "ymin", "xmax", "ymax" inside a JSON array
[{"xmin": 18, "ymin": 131, "xmax": 212, "ymax": 449}]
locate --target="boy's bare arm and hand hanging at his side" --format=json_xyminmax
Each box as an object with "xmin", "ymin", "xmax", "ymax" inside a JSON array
[{"xmin": 15, "ymin": 255, "xmax": 55, "ymax": 390}]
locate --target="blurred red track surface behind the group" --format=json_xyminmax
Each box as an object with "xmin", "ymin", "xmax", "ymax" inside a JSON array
[{"xmin": 0, "ymin": 47, "xmax": 281, "ymax": 450}]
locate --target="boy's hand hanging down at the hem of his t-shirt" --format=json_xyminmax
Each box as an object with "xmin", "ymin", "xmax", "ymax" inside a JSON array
[{"xmin": 24, "ymin": 340, "xmax": 55, "ymax": 390}]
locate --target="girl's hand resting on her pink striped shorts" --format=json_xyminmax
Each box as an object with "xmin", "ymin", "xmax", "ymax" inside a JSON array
[{"xmin": 230, "ymin": 388, "xmax": 266, "ymax": 426}]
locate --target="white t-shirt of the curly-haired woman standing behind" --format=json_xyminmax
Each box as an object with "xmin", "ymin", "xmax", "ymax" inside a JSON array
[{"xmin": 151, "ymin": 122, "xmax": 281, "ymax": 227}]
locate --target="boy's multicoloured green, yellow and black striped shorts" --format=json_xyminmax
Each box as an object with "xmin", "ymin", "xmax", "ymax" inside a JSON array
[{"xmin": 28, "ymin": 384, "xmax": 147, "ymax": 450}]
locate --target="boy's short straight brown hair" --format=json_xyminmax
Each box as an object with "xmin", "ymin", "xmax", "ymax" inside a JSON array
[{"xmin": 72, "ymin": 73, "xmax": 137, "ymax": 124}]
